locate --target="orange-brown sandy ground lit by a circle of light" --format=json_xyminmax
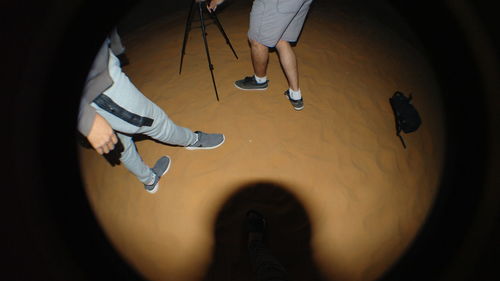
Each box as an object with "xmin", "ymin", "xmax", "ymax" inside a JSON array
[{"xmin": 81, "ymin": 0, "xmax": 444, "ymax": 281}]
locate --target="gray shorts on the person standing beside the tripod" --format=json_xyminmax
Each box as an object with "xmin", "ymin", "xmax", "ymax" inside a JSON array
[{"xmin": 248, "ymin": 0, "xmax": 313, "ymax": 47}]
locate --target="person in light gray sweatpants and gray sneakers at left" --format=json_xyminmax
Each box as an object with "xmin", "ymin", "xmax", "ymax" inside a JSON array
[{"xmin": 78, "ymin": 35, "xmax": 225, "ymax": 193}]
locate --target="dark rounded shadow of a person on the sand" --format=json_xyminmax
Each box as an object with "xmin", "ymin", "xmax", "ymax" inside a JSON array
[{"xmin": 203, "ymin": 182, "xmax": 326, "ymax": 281}]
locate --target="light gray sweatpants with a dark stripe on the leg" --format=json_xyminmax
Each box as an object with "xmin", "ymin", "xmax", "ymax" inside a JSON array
[{"xmin": 92, "ymin": 51, "xmax": 197, "ymax": 184}]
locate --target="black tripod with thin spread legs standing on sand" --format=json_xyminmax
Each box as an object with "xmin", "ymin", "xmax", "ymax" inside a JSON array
[{"xmin": 179, "ymin": 0, "xmax": 238, "ymax": 101}]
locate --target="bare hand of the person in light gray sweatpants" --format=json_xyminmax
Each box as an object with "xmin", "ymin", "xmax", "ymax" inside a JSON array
[{"xmin": 87, "ymin": 114, "xmax": 118, "ymax": 155}]
